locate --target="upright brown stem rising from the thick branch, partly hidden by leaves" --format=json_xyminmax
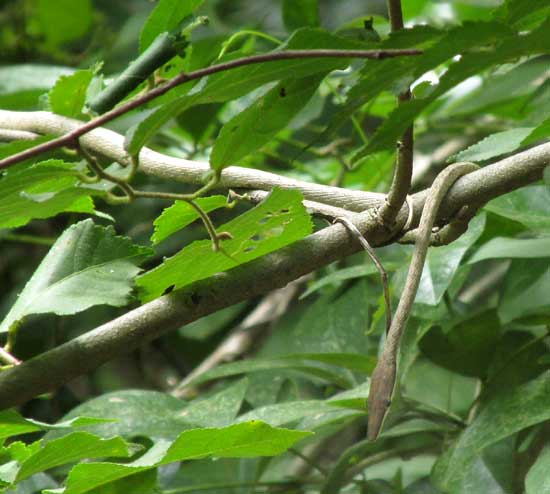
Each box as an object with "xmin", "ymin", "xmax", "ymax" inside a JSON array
[{"xmin": 380, "ymin": 0, "xmax": 414, "ymax": 224}]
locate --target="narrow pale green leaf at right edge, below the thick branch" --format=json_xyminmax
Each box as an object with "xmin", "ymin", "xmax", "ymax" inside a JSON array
[{"xmin": 468, "ymin": 237, "xmax": 550, "ymax": 264}]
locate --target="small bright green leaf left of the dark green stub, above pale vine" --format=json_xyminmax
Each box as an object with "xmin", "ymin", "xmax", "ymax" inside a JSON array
[{"xmin": 48, "ymin": 70, "xmax": 94, "ymax": 118}]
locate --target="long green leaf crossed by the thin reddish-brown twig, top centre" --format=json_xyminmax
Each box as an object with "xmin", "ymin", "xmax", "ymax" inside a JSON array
[{"xmin": 125, "ymin": 28, "xmax": 364, "ymax": 156}]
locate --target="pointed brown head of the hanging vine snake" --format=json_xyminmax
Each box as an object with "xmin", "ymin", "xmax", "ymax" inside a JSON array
[{"xmin": 367, "ymin": 358, "xmax": 397, "ymax": 441}]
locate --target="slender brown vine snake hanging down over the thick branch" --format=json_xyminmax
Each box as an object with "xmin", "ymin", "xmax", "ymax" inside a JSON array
[{"xmin": 367, "ymin": 163, "xmax": 478, "ymax": 441}]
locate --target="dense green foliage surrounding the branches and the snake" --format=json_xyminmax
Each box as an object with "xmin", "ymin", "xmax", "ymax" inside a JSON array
[{"xmin": 0, "ymin": 0, "xmax": 550, "ymax": 494}]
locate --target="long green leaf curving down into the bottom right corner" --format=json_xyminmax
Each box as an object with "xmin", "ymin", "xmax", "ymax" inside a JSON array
[{"xmin": 433, "ymin": 372, "xmax": 550, "ymax": 492}]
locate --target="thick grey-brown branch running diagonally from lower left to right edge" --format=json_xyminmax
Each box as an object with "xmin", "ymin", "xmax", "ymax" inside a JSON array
[{"xmin": 0, "ymin": 140, "xmax": 550, "ymax": 408}]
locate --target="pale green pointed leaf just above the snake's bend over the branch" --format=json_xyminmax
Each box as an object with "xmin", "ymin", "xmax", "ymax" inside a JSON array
[{"xmin": 453, "ymin": 127, "xmax": 533, "ymax": 161}]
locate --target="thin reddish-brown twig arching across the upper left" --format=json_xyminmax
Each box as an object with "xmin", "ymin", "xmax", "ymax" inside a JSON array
[{"xmin": 0, "ymin": 49, "xmax": 422, "ymax": 169}]
